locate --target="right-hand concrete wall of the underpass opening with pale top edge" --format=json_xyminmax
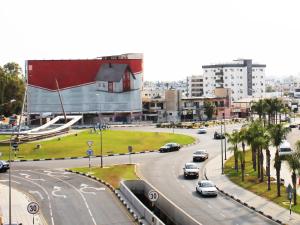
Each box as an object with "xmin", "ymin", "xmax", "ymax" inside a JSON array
[{"xmin": 121, "ymin": 180, "xmax": 201, "ymax": 225}]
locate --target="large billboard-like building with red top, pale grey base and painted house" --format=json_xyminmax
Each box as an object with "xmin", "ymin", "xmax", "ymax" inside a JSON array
[{"xmin": 26, "ymin": 53, "xmax": 143, "ymax": 123}]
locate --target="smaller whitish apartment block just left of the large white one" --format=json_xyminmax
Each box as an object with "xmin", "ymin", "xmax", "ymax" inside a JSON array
[{"xmin": 187, "ymin": 75, "xmax": 203, "ymax": 98}]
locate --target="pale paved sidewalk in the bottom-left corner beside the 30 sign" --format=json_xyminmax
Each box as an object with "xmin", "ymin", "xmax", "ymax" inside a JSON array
[{"xmin": 0, "ymin": 183, "xmax": 46, "ymax": 225}]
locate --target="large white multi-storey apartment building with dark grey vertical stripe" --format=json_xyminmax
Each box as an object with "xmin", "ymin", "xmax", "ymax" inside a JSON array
[{"xmin": 202, "ymin": 59, "xmax": 266, "ymax": 102}]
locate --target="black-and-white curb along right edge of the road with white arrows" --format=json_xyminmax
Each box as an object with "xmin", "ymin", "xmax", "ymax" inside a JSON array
[{"xmin": 65, "ymin": 169, "xmax": 144, "ymax": 225}]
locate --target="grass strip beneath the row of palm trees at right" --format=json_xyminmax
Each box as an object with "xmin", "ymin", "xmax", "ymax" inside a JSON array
[{"xmin": 224, "ymin": 151, "xmax": 300, "ymax": 213}]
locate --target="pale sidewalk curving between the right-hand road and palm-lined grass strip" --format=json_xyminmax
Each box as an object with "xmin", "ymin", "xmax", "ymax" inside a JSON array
[{"xmin": 206, "ymin": 155, "xmax": 300, "ymax": 225}]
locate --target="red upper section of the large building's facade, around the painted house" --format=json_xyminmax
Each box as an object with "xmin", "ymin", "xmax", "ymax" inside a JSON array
[{"xmin": 27, "ymin": 59, "xmax": 142, "ymax": 90}]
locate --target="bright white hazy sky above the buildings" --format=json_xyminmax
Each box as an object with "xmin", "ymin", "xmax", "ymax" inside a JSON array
[{"xmin": 0, "ymin": 0, "xmax": 300, "ymax": 80}]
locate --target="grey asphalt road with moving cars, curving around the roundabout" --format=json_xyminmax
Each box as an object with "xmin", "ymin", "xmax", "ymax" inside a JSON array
[{"xmin": 2, "ymin": 125, "xmax": 275, "ymax": 225}]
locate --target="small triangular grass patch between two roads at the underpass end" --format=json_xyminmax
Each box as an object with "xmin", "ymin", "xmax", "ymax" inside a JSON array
[{"xmin": 71, "ymin": 164, "xmax": 139, "ymax": 188}]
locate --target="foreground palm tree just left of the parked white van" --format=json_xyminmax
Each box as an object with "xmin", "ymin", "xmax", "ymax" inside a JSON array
[{"xmin": 269, "ymin": 123, "xmax": 289, "ymax": 197}]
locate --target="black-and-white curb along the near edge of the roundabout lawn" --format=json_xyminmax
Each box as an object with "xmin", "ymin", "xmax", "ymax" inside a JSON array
[{"xmin": 7, "ymin": 139, "xmax": 199, "ymax": 162}]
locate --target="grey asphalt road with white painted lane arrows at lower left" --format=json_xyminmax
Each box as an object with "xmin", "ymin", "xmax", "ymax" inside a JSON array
[{"xmin": 0, "ymin": 165, "xmax": 135, "ymax": 225}]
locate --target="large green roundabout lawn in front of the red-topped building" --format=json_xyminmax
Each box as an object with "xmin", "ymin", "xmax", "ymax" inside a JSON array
[{"xmin": 0, "ymin": 130, "xmax": 194, "ymax": 159}]
